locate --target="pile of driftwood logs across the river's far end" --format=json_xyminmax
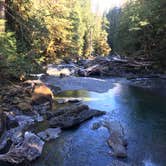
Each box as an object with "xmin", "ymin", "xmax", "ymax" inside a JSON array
[{"xmin": 77, "ymin": 57, "xmax": 158, "ymax": 77}]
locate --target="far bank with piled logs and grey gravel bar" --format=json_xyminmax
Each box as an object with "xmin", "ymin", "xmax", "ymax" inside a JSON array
[{"xmin": 44, "ymin": 56, "xmax": 166, "ymax": 95}]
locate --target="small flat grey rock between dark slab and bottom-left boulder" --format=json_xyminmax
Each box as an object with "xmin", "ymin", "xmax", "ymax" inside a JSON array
[{"xmin": 37, "ymin": 128, "xmax": 61, "ymax": 141}]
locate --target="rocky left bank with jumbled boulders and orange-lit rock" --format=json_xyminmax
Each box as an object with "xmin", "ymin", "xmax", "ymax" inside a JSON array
[{"xmin": 0, "ymin": 80, "xmax": 105, "ymax": 164}]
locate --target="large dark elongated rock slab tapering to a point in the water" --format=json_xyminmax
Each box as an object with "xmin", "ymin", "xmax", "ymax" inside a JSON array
[{"xmin": 49, "ymin": 105, "xmax": 105, "ymax": 129}]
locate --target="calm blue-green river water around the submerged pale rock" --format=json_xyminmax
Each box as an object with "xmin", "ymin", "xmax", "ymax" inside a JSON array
[{"xmin": 33, "ymin": 77, "xmax": 166, "ymax": 166}]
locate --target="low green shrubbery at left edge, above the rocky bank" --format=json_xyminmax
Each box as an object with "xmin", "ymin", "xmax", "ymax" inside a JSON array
[{"xmin": 0, "ymin": 32, "xmax": 41, "ymax": 78}]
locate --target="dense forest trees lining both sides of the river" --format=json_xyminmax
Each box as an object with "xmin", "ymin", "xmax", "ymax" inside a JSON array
[{"xmin": 0, "ymin": 0, "xmax": 166, "ymax": 79}]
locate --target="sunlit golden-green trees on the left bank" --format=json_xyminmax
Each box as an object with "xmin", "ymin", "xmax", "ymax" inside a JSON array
[{"xmin": 0, "ymin": 0, "xmax": 110, "ymax": 79}]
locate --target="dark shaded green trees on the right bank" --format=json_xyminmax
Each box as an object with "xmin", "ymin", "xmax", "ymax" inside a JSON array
[{"xmin": 107, "ymin": 0, "xmax": 166, "ymax": 58}]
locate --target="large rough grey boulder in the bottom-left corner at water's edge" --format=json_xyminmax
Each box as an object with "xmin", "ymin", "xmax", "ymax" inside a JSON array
[{"xmin": 0, "ymin": 132, "xmax": 44, "ymax": 164}]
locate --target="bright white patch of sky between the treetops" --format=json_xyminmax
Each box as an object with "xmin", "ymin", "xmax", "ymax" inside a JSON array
[{"xmin": 91, "ymin": 0, "xmax": 124, "ymax": 13}]
